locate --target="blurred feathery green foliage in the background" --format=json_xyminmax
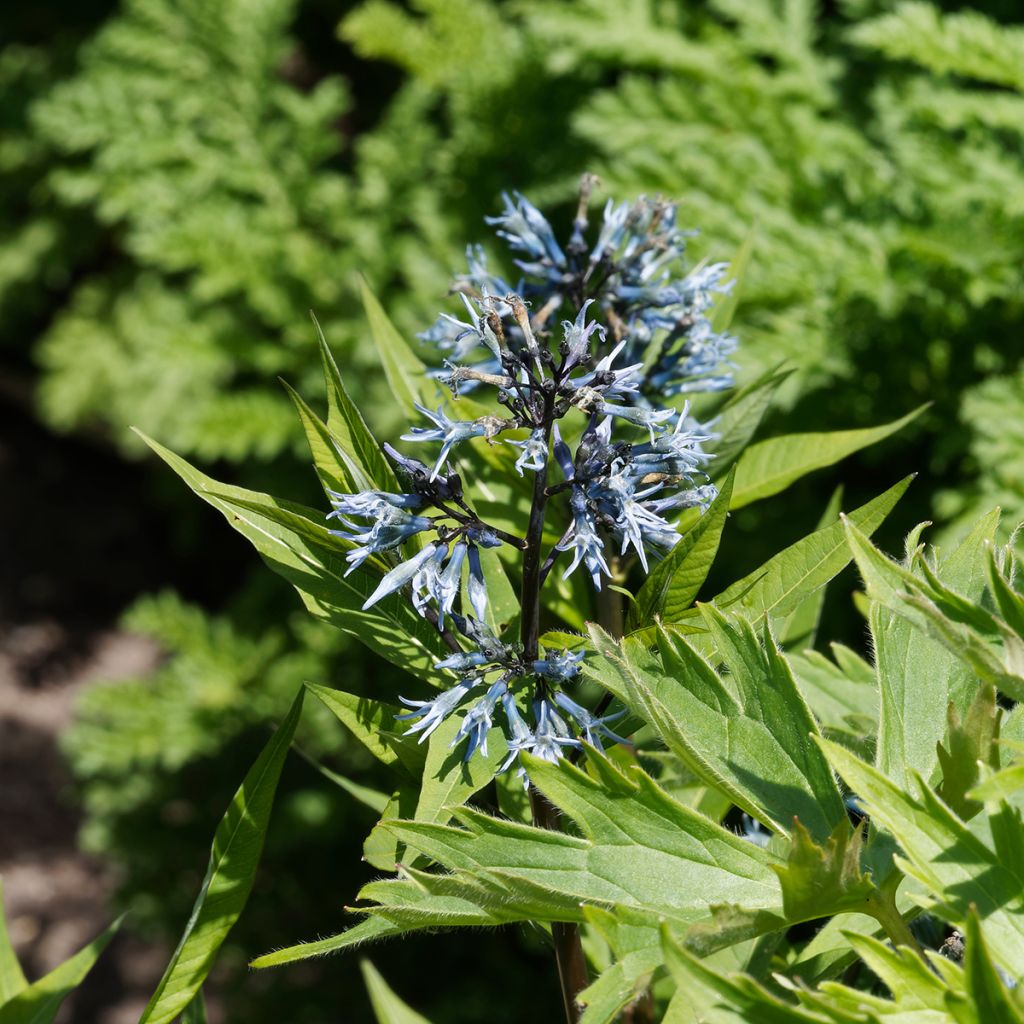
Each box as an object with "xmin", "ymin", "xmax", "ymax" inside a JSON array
[{"xmin": 6, "ymin": 0, "xmax": 1024, "ymax": 1020}]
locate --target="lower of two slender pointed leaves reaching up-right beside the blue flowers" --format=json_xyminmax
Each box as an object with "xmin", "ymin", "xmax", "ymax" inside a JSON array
[{"xmin": 714, "ymin": 476, "xmax": 913, "ymax": 622}]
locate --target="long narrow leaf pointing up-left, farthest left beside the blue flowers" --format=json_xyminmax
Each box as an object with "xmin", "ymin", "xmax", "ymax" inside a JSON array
[{"xmin": 139, "ymin": 434, "xmax": 451, "ymax": 684}]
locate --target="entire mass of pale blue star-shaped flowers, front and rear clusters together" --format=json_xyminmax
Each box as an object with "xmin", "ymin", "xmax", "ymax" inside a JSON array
[{"xmin": 321, "ymin": 186, "xmax": 735, "ymax": 770}]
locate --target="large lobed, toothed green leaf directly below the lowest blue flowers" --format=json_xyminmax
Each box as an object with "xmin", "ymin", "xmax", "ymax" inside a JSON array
[{"xmin": 388, "ymin": 752, "xmax": 778, "ymax": 925}]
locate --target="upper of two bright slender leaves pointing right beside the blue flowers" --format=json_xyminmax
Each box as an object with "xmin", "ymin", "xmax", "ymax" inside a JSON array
[{"xmin": 732, "ymin": 406, "xmax": 928, "ymax": 509}]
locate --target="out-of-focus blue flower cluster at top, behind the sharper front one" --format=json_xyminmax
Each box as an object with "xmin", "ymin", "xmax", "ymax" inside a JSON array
[{"xmin": 420, "ymin": 186, "xmax": 737, "ymax": 406}]
